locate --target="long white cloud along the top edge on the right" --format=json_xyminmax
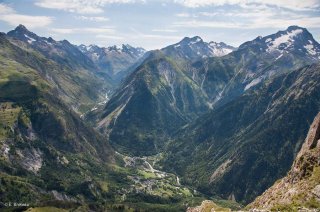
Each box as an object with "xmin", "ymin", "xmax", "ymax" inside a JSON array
[{"xmin": 174, "ymin": 0, "xmax": 320, "ymax": 10}]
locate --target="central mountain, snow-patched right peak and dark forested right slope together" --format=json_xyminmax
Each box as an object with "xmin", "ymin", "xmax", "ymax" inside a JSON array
[{"xmin": 97, "ymin": 26, "xmax": 319, "ymax": 204}]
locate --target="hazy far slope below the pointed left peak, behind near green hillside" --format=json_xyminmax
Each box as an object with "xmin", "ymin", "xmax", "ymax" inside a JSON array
[{"xmin": 0, "ymin": 26, "xmax": 112, "ymax": 113}]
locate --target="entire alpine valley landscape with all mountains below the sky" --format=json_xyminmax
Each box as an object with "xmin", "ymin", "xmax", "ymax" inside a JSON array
[{"xmin": 0, "ymin": 25, "xmax": 320, "ymax": 211}]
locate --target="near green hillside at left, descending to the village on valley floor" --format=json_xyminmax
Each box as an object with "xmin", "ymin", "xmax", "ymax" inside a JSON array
[{"xmin": 0, "ymin": 34, "xmax": 210, "ymax": 211}]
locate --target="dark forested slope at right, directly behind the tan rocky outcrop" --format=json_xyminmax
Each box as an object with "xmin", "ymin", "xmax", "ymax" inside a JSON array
[{"xmin": 163, "ymin": 65, "xmax": 320, "ymax": 203}]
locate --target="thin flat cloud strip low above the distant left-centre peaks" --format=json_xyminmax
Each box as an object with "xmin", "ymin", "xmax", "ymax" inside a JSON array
[{"xmin": 50, "ymin": 27, "xmax": 115, "ymax": 34}]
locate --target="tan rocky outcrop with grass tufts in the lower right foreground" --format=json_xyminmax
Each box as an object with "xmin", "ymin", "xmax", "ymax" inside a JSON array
[{"xmin": 248, "ymin": 113, "xmax": 320, "ymax": 210}]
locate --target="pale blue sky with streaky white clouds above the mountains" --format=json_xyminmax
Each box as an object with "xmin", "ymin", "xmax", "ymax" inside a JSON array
[{"xmin": 0, "ymin": 0, "xmax": 320, "ymax": 50}]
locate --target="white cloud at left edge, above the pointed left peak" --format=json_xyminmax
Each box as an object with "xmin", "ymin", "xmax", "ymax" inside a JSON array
[{"xmin": 0, "ymin": 4, "xmax": 53, "ymax": 29}]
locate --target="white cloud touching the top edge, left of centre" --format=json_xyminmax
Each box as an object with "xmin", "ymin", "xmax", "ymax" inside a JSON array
[{"xmin": 35, "ymin": 0, "xmax": 144, "ymax": 14}]
